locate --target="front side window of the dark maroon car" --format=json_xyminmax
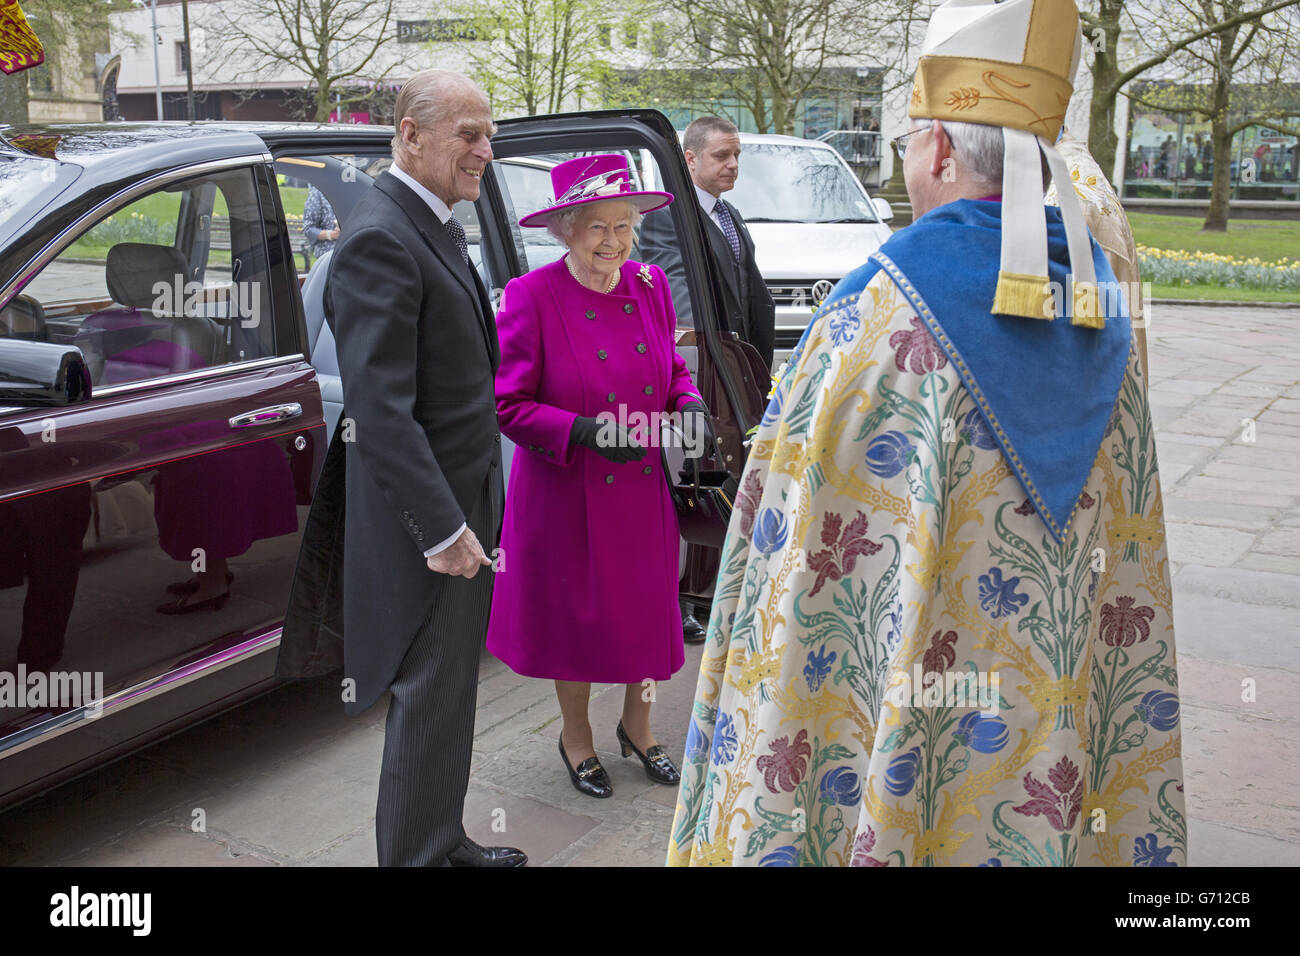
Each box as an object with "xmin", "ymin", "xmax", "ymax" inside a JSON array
[{"xmin": 13, "ymin": 169, "xmax": 276, "ymax": 386}]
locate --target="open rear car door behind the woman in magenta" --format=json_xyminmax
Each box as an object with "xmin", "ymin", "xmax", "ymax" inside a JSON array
[{"xmin": 486, "ymin": 109, "xmax": 771, "ymax": 602}]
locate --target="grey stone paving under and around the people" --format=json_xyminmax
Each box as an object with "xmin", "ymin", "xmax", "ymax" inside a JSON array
[{"xmin": 0, "ymin": 304, "xmax": 1300, "ymax": 866}]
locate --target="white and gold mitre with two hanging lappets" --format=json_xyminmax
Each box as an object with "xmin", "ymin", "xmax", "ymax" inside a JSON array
[{"xmin": 907, "ymin": 0, "xmax": 1104, "ymax": 328}]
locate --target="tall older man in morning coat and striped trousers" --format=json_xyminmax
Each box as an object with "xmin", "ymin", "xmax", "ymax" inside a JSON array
[{"xmin": 278, "ymin": 70, "xmax": 525, "ymax": 866}]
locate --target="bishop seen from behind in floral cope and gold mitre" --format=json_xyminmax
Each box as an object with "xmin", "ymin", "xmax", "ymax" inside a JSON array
[{"xmin": 668, "ymin": 0, "xmax": 1187, "ymax": 866}]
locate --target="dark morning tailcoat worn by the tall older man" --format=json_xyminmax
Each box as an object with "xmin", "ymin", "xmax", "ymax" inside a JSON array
[{"xmin": 277, "ymin": 173, "xmax": 501, "ymax": 714}]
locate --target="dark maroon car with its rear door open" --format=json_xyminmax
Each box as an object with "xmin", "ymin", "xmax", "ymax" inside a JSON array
[{"xmin": 0, "ymin": 111, "xmax": 768, "ymax": 806}]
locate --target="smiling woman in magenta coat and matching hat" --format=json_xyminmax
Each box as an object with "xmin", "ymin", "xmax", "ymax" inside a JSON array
[{"xmin": 488, "ymin": 155, "xmax": 707, "ymax": 797}]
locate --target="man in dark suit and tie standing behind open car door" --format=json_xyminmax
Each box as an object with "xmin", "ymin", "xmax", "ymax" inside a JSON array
[{"xmin": 640, "ymin": 116, "xmax": 776, "ymax": 368}]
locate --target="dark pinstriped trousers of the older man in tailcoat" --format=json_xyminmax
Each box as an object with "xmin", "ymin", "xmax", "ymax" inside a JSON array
[{"xmin": 374, "ymin": 468, "xmax": 502, "ymax": 866}]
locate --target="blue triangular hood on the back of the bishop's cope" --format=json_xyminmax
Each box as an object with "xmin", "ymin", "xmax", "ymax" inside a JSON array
[{"xmin": 863, "ymin": 199, "xmax": 1132, "ymax": 541}]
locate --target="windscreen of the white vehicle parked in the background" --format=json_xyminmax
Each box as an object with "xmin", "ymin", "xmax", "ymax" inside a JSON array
[{"xmin": 727, "ymin": 143, "xmax": 878, "ymax": 222}]
